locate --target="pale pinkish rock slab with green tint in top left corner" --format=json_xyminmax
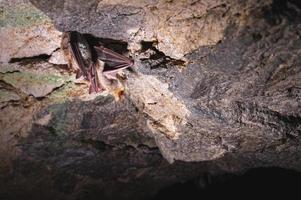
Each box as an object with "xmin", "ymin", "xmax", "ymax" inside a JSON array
[{"xmin": 0, "ymin": 0, "xmax": 61, "ymax": 63}]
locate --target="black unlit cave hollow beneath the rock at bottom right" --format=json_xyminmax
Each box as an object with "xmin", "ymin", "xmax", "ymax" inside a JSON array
[{"xmin": 152, "ymin": 168, "xmax": 301, "ymax": 200}]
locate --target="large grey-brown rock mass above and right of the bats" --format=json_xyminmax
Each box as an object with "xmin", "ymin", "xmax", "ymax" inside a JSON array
[{"xmin": 31, "ymin": 0, "xmax": 301, "ymax": 168}]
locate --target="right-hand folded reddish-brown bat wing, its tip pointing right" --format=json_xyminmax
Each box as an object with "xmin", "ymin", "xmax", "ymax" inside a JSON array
[{"xmin": 94, "ymin": 46, "xmax": 134, "ymax": 73}]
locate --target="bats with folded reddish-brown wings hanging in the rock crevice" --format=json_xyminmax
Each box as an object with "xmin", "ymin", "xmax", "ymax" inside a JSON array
[{"xmin": 61, "ymin": 31, "xmax": 134, "ymax": 100}]
